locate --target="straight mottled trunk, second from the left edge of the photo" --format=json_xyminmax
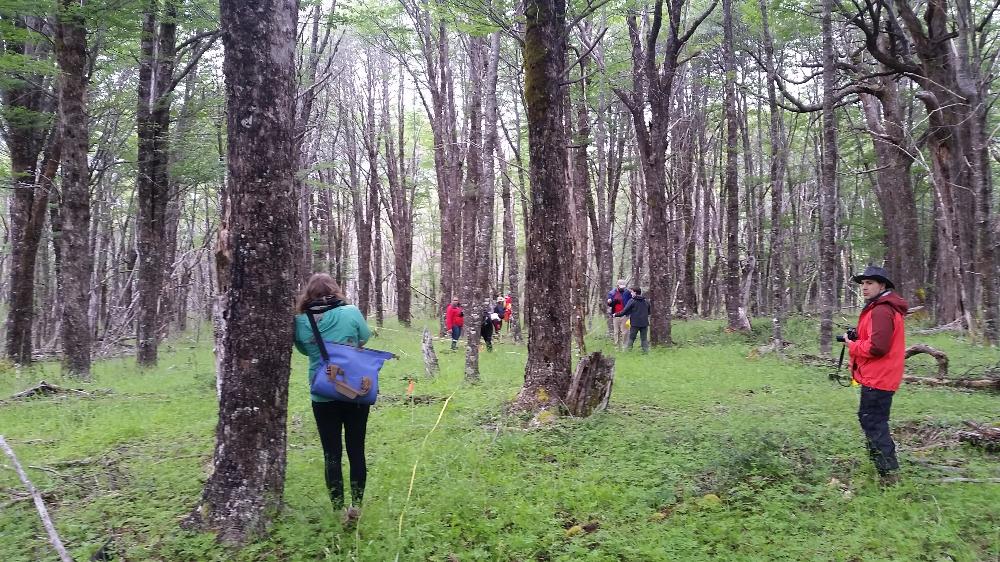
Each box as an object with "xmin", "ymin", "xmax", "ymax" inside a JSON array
[{"xmin": 56, "ymin": 0, "xmax": 94, "ymax": 379}]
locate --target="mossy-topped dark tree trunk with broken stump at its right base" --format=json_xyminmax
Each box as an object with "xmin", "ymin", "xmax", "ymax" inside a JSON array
[{"xmin": 517, "ymin": 0, "xmax": 573, "ymax": 410}]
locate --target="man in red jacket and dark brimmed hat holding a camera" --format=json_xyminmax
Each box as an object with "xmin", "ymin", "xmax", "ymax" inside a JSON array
[{"xmin": 844, "ymin": 265, "xmax": 908, "ymax": 485}]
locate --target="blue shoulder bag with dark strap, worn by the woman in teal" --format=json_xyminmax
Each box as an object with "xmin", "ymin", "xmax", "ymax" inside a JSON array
[{"xmin": 306, "ymin": 300, "xmax": 396, "ymax": 404}]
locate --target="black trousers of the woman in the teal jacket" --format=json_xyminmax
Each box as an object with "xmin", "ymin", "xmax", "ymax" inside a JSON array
[{"xmin": 313, "ymin": 402, "xmax": 371, "ymax": 508}]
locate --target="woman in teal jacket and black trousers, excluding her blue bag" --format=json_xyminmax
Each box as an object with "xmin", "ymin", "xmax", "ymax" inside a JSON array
[{"xmin": 295, "ymin": 273, "xmax": 371, "ymax": 523}]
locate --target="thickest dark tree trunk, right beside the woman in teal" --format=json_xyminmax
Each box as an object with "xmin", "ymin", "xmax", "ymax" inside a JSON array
[{"xmin": 188, "ymin": 0, "xmax": 302, "ymax": 544}]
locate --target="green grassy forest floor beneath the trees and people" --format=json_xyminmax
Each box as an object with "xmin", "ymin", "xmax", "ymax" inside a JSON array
[{"xmin": 0, "ymin": 318, "xmax": 1000, "ymax": 562}]
